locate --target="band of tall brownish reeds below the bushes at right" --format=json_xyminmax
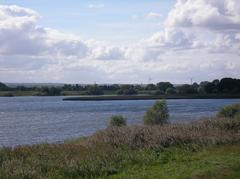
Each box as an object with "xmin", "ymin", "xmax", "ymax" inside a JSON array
[{"xmin": 85, "ymin": 118, "xmax": 240, "ymax": 149}]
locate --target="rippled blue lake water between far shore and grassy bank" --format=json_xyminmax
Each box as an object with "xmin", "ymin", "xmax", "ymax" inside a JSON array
[{"xmin": 0, "ymin": 97, "xmax": 240, "ymax": 146}]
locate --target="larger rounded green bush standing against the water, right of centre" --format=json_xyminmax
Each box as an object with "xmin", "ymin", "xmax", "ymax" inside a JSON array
[{"xmin": 144, "ymin": 101, "xmax": 169, "ymax": 125}]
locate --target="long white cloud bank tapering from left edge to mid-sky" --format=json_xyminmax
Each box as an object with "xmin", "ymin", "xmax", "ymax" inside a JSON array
[{"xmin": 0, "ymin": 6, "xmax": 124, "ymax": 60}]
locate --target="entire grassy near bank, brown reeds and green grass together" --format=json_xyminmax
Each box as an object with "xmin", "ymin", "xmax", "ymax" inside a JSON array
[{"xmin": 0, "ymin": 119, "xmax": 240, "ymax": 178}]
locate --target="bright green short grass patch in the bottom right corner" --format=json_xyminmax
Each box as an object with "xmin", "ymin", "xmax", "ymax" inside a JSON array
[{"xmin": 111, "ymin": 144, "xmax": 240, "ymax": 179}]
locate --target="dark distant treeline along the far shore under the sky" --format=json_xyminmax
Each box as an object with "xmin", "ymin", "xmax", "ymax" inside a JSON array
[{"xmin": 0, "ymin": 78, "xmax": 240, "ymax": 96}]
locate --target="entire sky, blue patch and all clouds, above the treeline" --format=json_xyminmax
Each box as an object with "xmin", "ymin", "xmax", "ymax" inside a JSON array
[{"xmin": 0, "ymin": 0, "xmax": 240, "ymax": 83}]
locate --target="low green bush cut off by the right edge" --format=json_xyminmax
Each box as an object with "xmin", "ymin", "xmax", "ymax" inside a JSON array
[{"xmin": 217, "ymin": 104, "xmax": 240, "ymax": 118}]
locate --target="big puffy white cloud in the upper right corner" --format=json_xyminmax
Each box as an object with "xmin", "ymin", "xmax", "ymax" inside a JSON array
[{"xmin": 162, "ymin": 0, "xmax": 240, "ymax": 55}]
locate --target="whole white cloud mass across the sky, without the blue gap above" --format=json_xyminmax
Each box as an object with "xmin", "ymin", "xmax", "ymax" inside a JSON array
[{"xmin": 0, "ymin": 3, "xmax": 240, "ymax": 83}]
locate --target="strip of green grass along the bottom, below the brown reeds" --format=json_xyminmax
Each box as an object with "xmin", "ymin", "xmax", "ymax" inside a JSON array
[{"xmin": 0, "ymin": 143, "xmax": 240, "ymax": 179}]
